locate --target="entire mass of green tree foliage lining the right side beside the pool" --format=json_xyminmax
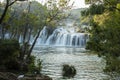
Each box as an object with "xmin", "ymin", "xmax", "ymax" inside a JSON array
[{"xmin": 86, "ymin": 0, "xmax": 120, "ymax": 73}]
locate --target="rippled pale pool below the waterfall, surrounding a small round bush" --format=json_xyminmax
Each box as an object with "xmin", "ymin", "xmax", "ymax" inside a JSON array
[{"xmin": 33, "ymin": 47, "xmax": 113, "ymax": 80}]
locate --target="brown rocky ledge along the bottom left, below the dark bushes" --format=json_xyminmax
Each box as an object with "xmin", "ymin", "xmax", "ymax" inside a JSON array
[{"xmin": 0, "ymin": 72, "xmax": 52, "ymax": 80}]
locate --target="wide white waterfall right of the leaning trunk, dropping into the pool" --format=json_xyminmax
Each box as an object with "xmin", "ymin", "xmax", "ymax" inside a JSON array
[{"xmin": 36, "ymin": 27, "xmax": 88, "ymax": 47}]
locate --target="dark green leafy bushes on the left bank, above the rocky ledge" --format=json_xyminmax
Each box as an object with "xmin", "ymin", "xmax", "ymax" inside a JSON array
[{"xmin": 0, "ymin": 39, "xmax": 42, "ymax": 73}]
